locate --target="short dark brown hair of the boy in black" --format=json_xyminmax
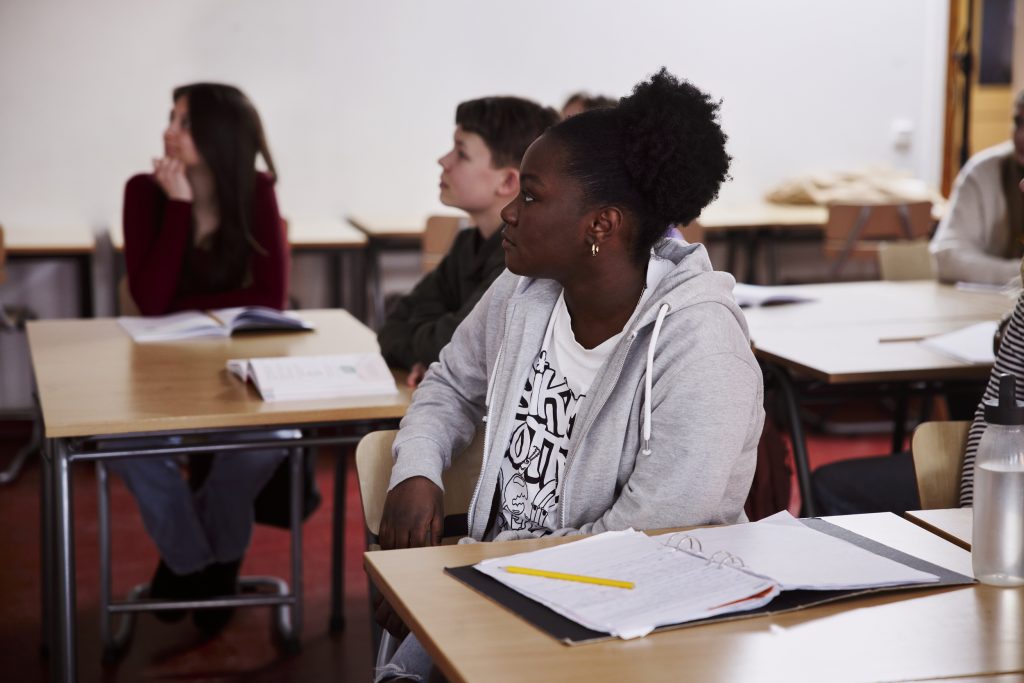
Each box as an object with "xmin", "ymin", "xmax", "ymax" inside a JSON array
[{"xmin": 455, "ymin": 96, "xmax": 559, "ymax": 168}]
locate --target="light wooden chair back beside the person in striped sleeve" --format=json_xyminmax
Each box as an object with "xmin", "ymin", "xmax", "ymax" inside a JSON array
[{"xmin": 910, "ymin": 421, "xmax": 971, "ymax": 510}]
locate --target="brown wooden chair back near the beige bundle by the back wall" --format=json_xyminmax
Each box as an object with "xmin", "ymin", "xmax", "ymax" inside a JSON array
[{"xmin": 824, "ymin": 201, "xmax": 932, "ymax": 278}]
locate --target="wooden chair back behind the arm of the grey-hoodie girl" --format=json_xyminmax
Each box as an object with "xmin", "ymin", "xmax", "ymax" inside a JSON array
[{"xmin": 355, "ymin": 429, "xmax": 483, "ymax": 538}]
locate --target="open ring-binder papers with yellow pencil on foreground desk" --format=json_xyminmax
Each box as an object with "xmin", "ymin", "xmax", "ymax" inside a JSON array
[{"xmin": 475, "ymin": 512, "xmax": 939, "ymax": 638}]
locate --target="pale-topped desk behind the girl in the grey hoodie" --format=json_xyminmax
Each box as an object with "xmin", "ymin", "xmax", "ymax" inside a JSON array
[{"xmin": 744, "ymin": 282, "xmax": 1014, "ymax": 514}]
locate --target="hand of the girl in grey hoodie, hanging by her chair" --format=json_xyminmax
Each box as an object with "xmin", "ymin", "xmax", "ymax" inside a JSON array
[{"xmin": 379, "ymin": 476, "xmax": 444, "ymax": 550}]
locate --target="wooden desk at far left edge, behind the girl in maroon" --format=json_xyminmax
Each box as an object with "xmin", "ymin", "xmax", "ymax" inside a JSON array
[{"xmin": 3, "ymin": 223, "xmax": 96, "ymax": 317}]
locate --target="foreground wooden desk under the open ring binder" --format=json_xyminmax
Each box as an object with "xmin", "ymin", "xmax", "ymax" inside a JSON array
[{"xmin": 365, "ymin": 513, "xmax": 1024, "ymax": 683}]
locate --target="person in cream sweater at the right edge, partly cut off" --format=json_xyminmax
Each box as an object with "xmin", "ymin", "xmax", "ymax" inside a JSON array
[{"xmin": 931, "ymin": 91, "xmax": 1024, "ymax": 285}]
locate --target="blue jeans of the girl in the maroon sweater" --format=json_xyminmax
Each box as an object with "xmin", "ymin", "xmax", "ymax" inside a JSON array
[{"xmin": 108, "ymin": 431, "xmax": 294, "ymax": 574}]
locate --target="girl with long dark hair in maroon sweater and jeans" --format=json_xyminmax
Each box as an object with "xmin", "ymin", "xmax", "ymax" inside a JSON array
[{"xmin": 110, "ymin": 83, "xmax": 288, "ymax": 632}]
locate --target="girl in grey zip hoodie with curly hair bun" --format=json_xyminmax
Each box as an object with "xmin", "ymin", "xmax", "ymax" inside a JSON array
[{"xmin": 378, "ymin": 70, "xmax": 764, "ymax": 676}]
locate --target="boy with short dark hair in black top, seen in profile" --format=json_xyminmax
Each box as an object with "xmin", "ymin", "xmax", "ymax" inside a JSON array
[{"xmin": 378, "ymin": 97, "xmax": 558, "ymax": 386}]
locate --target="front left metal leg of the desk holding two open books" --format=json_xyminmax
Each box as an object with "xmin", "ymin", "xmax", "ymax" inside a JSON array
[{"xmin": 51, "ymin": 439, "xmax": 78, "ymax": 681}]
